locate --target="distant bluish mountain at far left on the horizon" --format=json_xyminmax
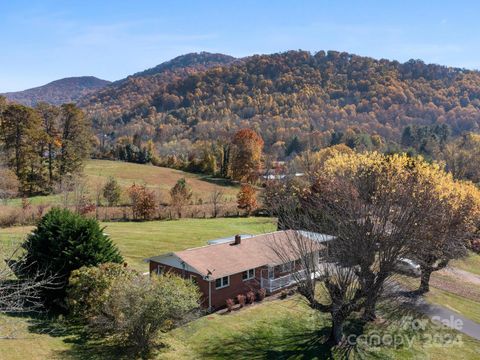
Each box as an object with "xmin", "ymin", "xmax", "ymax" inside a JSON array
[{"xmin": 2, "ymin": 76, "xmax": 110, "ymax": 106}]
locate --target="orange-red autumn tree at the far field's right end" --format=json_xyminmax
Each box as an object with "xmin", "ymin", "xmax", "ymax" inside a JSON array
[{"xmin": 231, "ymin": 129, "xmax": 263, "ymax": 182}]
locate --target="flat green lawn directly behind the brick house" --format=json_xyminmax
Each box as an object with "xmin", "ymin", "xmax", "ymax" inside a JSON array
[{"xmin": 0, "ymin": 217, "xmax": 276, "ymax": 271}]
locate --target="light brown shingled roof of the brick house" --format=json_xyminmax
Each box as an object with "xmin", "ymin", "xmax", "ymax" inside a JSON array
[{"xmin": 149, "ymin": 230, "xmax": 328, "ymax": 279}]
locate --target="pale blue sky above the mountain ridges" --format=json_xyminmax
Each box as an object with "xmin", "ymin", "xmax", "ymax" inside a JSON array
[{"xmin": 0, "ymin": 0, "xmax": 480, "ymax": 92}]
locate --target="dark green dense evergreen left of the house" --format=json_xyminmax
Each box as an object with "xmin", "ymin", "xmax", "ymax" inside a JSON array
[{"xmin": 18, "ymin": 208, "xmax": 123, "ymax": 302}]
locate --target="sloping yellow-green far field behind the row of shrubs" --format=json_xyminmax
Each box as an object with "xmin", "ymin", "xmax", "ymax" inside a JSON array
[{"xmin": 4, "ymin": 160, "xmax": 238, "ymax": 206}]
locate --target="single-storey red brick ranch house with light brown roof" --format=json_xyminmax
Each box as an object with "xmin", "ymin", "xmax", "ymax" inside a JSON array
[{"xmin": 146, "ymin": 230, "xmax": 333, "ymax": 311}]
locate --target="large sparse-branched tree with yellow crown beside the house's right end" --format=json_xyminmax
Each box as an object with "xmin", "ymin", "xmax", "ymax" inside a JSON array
[{"xmin": 267, "ymin": 153, "xmax": 478, "ymax": 342}]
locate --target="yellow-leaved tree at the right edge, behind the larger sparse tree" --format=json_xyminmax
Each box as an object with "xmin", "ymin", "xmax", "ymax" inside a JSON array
[{"xmin": 409, "ymin": 164, "xmax": 480, "ymax": 293}]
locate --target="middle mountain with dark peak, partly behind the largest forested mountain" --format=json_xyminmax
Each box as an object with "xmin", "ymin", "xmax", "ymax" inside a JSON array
[{"xmin": 78, "ymin": 52, "xmax": 237, "ymax": 118}]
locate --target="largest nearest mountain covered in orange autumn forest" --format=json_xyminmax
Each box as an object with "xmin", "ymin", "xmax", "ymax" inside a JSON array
[{"xmin": 93, "ymin": 51, "xmax": 480, "ymax": 154}]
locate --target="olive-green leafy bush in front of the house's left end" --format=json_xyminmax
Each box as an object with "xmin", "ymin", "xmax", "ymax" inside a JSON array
[{"xmin": 90, "ymin": 274, "xmax": 200, "ymax": 358}]
